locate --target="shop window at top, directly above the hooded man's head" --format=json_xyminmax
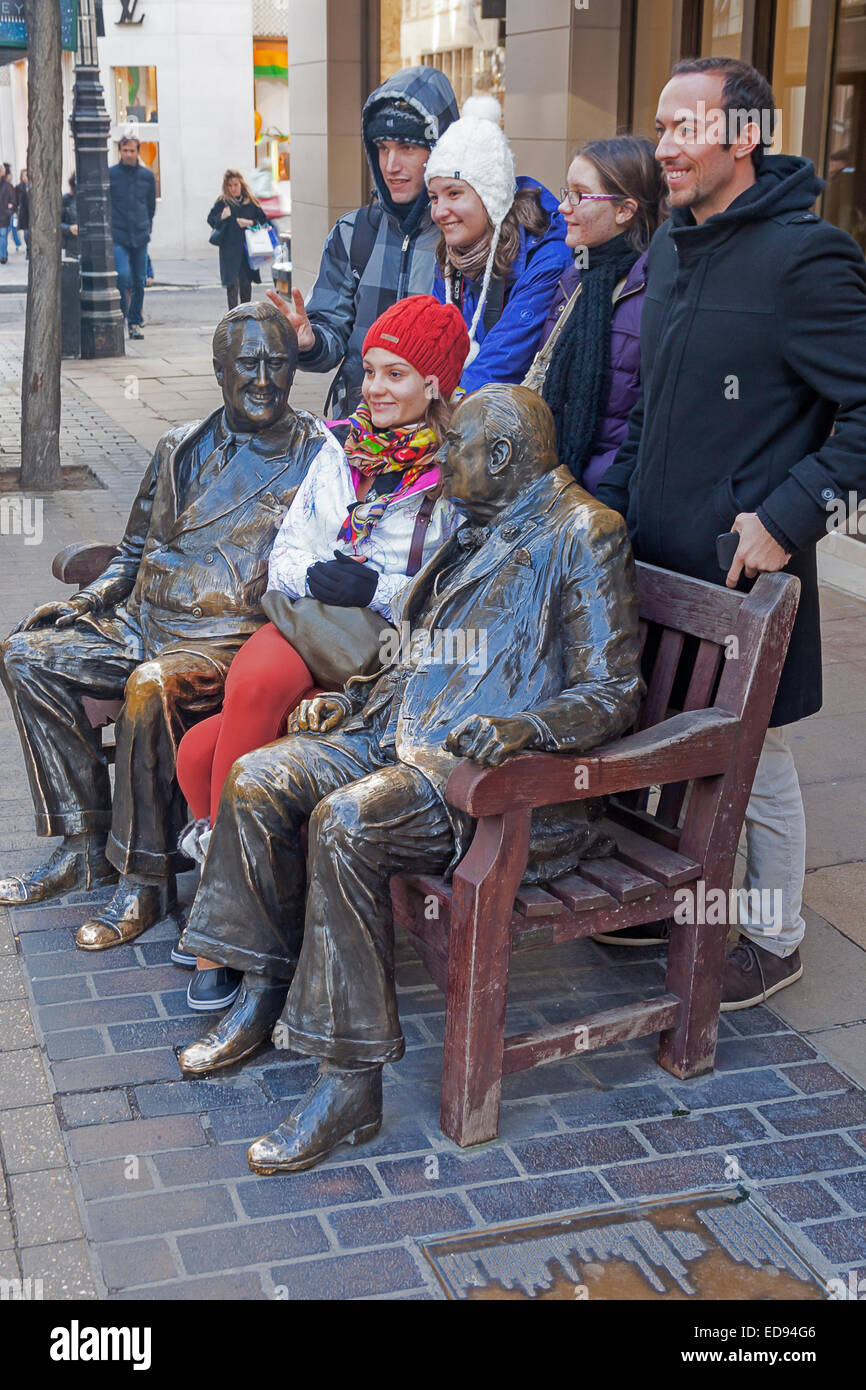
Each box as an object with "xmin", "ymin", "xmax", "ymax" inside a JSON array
[{"xmin": 379, "ymin": 0, "xmax": 506, "ymax": 106}]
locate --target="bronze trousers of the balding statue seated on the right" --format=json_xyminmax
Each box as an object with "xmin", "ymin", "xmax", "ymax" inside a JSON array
[{"xmin": 182, "ymin": 721, "xmax": 455, "ymax": 1063}]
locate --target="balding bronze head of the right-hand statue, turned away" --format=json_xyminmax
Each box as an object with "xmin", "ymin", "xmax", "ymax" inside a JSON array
[{"xmin": 436, "ymin": 385, "xmax": 557, "ymax": 523}]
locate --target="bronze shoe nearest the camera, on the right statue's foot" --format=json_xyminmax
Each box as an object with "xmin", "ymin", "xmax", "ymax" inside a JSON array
[{"xmin": 247, "ymin": 1063, "xmax": 382, "ymax": 1176}]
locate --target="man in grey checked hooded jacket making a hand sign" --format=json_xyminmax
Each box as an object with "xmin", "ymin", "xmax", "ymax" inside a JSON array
[{"xmin": 268, "ymin": 67, "xmax": 459, "ymax": 418}]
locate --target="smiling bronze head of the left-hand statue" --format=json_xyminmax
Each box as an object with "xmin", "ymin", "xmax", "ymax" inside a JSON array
[{"xmin": 213, "ymin": 300, "xmax": 297, "ymax": 434}]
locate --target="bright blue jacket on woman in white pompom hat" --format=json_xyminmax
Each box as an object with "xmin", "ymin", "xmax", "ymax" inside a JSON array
[{"xmin": 432, "ymin": 178, "xmax": 573, "ymax": 391}]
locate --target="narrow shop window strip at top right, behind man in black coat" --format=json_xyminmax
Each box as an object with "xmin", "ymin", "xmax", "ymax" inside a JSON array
[{"xmin": 823, "ymin": 0, "xmax": 866, "ymax": 252}]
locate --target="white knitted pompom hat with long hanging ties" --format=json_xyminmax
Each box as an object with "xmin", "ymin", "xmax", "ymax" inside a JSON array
[{"xmin": 424, "ymin": 96, "xmax": 517, "ymax": 361}]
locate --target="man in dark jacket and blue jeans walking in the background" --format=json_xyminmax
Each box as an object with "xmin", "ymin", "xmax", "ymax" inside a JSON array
[{"xmin": 108, "ymin": 135, "xmax": 156, "ymax": 338}]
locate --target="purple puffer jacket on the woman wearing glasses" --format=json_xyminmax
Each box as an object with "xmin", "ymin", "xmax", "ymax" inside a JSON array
[{"xmin": 538, "ymin": 252, "xmax": 646, "ymax": 495}]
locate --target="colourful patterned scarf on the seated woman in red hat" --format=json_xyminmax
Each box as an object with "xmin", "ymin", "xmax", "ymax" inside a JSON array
[{"xmin": 338, "ymin": 403, "xmax": 439, "ymax": 548}]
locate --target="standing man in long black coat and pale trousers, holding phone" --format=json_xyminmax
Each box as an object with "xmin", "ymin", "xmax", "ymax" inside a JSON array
[{"xmin": 598, "ymin": 58, "xmax": 866, "ymax": 1011}]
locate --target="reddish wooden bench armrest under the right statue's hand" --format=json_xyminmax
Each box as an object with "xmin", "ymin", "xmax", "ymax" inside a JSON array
[{"xmin": 445, "ymin": 709, "xmax": 741, "ymax": 816}]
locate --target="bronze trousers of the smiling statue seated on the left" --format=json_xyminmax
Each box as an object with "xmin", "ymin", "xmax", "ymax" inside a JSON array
[{"xmin": 0, "ymin": 609, "xmax": 240, "ymax": 874}]
